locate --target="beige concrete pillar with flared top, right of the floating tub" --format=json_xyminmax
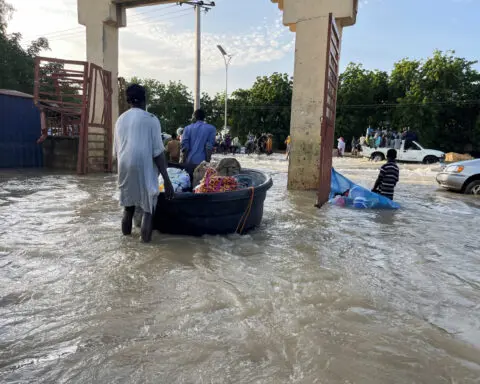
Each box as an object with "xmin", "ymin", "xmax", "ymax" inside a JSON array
[{"xmin": 272, "ymin": 0, "xmax": 358, "ymax": 190}]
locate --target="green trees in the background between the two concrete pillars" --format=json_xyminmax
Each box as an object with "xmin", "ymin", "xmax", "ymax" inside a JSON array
[{"xmin": 129, "ymin": 73, "xmax": 293, "ymax": 144}]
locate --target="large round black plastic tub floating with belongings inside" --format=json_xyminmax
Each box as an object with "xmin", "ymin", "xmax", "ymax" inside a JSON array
[{"xmin": 154, "ymin": 169, "xmax": 273, "ymax": 236}]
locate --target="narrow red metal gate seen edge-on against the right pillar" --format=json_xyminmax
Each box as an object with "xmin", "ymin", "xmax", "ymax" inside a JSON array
[{"xmin": 317, "ymin": 14, "xmax": 341, "ymax": 207}]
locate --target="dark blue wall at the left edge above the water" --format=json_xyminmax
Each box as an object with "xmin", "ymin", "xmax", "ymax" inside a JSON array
[{"xmin": 0, "ymin": 94, "xmax": 43, "ymax": 168}]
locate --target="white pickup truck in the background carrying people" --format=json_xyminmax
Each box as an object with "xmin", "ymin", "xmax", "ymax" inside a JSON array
[{"xmin": 362, "ymin": 140, "xmax": 445, "ymax": 164}]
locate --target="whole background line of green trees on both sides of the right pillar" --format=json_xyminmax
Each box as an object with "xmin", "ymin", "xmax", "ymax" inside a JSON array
[{"xmin": 132, "ymin": 51, "xmax": 480, "ymax": 152}]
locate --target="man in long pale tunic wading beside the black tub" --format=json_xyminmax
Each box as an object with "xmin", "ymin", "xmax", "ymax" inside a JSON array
[{"xmin": 115, "ymin": 84, "xmax": 174, "ymax": 243}]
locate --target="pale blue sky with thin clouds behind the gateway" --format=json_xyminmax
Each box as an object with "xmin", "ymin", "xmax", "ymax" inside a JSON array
[{"xmin": 8, "ymin": 0, "xmax": 480, "ymax": 93}]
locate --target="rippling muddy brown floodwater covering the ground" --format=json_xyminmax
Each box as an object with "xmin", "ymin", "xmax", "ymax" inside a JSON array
[{"xmin": 0, "ymin": 156, "xmax": 480, "ymax": 384}]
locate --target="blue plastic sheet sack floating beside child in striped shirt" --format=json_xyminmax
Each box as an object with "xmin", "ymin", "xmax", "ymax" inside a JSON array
[{"xmin": 329, "ymin": 169, "xmax": 400, "ymax": 209}]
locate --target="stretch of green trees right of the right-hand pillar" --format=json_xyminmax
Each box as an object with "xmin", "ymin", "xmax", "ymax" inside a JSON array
[{"xmin": 336, "ymin": 51, "xmax": 480, "ymax": 152}]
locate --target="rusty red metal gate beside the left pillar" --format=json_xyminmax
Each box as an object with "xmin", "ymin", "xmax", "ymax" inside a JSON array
[{"xmin": 35, "ymin": 57, "xmax": 113, "ymax": 174}]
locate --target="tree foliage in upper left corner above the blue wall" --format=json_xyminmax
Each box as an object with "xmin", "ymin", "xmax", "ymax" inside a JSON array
[{"xmin": 0, "ymin": 0, "xmax": 49, "ymax": 93}]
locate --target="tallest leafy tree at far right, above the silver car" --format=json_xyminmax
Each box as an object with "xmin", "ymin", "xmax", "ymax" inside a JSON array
[{"xmin": 392, "ymin": 51, "xmax": 480, "ymax": 152}]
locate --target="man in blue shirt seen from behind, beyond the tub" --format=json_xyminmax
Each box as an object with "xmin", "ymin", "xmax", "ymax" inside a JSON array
[{"xmin": 182, "ymin": 109, "xmax": 217, "ymax": 167}]
